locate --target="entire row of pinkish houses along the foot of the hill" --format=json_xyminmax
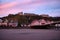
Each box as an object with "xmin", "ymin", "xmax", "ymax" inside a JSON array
[{"xmin": 0, "ymin": 19, "xmax": 60, "ymax": 27}]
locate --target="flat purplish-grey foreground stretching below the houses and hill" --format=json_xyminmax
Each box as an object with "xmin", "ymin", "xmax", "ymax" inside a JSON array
[{"xmin": 0, "ymin": 29, "xmax": 60, "ymax": 40}]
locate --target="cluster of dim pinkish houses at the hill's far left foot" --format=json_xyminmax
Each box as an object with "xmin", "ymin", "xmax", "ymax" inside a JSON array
[{"xmin": 0, "ymin": 19, "xmax": 18, "ymax": 27}]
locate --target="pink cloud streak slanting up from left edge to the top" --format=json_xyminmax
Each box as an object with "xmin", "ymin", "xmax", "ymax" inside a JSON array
[{"xmin": 0, "ymin": 0, "xmax": 30, "ymax": 9}]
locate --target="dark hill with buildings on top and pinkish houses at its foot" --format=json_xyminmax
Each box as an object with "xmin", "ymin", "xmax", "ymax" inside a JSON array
[{"xmin": 0, "ymin": 12, "xmax": 60, "ymax": 27}]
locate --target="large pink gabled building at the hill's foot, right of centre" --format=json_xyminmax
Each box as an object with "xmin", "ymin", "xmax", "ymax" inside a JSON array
[{"xmin": 30, "ymin": 19, "xmax": 52, "ymax": 26}]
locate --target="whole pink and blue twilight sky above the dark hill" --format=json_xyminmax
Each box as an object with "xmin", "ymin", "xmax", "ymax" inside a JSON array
[{"xmin": 0, "ymin": 0, "xmax": 60, "ymax": 17}]
